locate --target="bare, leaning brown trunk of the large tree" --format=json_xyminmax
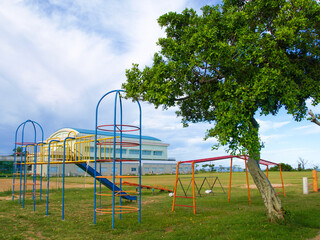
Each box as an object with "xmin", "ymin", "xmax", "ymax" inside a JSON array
[{"xmin": 248, "ymin": 156, "xmax": 284, "ymax": 222}]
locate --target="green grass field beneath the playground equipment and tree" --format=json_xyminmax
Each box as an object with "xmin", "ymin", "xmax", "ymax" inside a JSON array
[{"xmin": 0, "ymin": 172, "xmax": 320, "ymax": 239}]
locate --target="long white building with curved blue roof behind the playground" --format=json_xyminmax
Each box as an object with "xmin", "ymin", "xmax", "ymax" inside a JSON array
[{"xmin": 37, "ymin": 128, "xmax": 191, "ymax": 176}]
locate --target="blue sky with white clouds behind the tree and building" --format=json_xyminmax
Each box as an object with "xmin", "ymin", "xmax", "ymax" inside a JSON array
[{"xmin": 0, "ymin": 0, "xmax": 320, "ymax": 168}]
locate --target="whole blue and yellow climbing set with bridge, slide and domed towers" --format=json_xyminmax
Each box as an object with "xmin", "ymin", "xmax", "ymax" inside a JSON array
[{"xmin": 12, "ymin": 90, "xmax": 141, "ymax": 228}]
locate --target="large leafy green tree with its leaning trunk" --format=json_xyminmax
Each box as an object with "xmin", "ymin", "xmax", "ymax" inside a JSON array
[{"xmin": 123, "ymin": 0, "xmax": 320, "ymax": 220}]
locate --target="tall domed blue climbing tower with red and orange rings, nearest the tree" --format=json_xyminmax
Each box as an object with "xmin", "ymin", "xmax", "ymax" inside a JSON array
[{"xmin": 93, "ymin": 90, "xmax": 142, "ymax": 228}]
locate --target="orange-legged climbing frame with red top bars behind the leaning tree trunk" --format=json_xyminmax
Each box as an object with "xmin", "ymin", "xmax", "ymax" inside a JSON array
[{"xmin": 172, "ymin": 155, "xmax": 286, "ymax": 214}]
